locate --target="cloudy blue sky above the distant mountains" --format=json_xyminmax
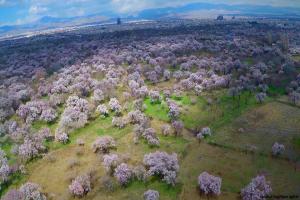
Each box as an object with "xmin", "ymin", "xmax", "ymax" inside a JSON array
[{"xmin": 0, "ymin": 0, "xmax": 300, "ymax": 25}]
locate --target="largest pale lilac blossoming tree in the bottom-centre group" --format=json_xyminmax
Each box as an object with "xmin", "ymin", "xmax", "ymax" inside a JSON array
[{"xmin": 144, "ymin": 151, "xmax": 179, "ymax": 186}]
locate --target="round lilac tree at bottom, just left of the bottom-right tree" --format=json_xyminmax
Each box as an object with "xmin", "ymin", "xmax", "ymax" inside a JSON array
[{"xmin": 198, "ymin": 172, "xmax": 222, "ymax": 195}]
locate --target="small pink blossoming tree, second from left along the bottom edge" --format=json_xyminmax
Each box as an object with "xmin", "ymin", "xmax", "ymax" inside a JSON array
[{"xmin": 69, "ymin": 175, "xmax": 91, "ymax": 197}]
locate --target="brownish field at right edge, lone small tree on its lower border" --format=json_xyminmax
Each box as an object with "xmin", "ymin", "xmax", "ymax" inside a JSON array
[{"xmin": 209, "ymin": 102, "xmax": 300, "ymax": 161}]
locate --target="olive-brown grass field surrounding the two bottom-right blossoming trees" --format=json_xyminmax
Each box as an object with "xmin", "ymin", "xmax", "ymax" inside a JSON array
[{"xmin": 179, "ymin": 142, "xmax": 300, "ymax": 200}]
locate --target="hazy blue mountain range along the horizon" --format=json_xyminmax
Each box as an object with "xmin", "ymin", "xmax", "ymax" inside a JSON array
[{"xmin": 0, "ymin": 3, "xmax": 300, "ymax": 36}]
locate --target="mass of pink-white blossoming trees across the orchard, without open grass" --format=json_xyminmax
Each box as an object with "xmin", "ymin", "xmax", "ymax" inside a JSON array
[{"xmin": 0, "ymin": 18, "xmax": 300, "ymax": 200}]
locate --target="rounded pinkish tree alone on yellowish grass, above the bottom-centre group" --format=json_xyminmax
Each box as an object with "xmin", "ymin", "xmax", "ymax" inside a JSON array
[{"xmin": 92, "ymin": 136, "xmax": 116, "ymax": 153}]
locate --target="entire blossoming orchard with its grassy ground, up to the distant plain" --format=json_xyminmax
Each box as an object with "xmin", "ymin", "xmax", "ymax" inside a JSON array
[{"xmin": 0, "ymin": 15, "xmax": 300, "ymax": 200}]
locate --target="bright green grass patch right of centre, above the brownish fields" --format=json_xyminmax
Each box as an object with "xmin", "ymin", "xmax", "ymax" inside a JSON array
[{"xmin": 181, "ymin": 90, "xmax": 264, "ymax": 130}]
